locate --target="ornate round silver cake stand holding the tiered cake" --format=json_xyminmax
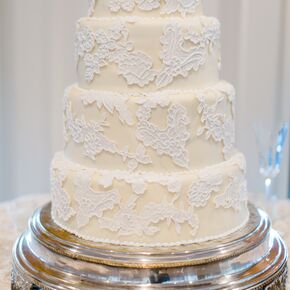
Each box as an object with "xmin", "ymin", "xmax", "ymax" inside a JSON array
[{"xmin": 12, "ymin": 204, "xmax": 287, "ymax": 290}]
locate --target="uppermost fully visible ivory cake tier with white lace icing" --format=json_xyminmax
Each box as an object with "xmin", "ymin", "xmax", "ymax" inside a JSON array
[{"xmin": 75, "ymin": 16, "xmax": 220, "ymax": 92}]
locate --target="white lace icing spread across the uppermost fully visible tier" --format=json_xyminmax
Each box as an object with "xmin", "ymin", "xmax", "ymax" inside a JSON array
[{"xmin": 75, "ymin": 18, "xmax": 220, "ymax": 88}]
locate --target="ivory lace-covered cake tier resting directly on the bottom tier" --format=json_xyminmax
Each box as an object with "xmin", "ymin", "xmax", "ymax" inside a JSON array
[{"xmin": 64, "ymin": 81, "xmax": 235, "ymax": 172}]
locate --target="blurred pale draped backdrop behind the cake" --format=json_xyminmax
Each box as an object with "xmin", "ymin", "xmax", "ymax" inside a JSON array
[{"xmin": 0, "ymin": 0, "xmax": 290, "ymax": 200}]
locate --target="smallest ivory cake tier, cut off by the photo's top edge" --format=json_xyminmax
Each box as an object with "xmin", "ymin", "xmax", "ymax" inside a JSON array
[{"xmin": 89, "ymin": 0, "xmax": 202, "ymax": 17}]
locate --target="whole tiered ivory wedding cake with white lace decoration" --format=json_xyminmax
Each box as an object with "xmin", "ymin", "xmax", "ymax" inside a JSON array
[{"xmin": 51, "ymin": 0, "xmax": 249, "ymax": 247}]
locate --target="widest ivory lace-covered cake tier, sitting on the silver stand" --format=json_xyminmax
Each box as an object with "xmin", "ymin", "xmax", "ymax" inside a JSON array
[{"xmin": 51, "ymin": 153, "xmax": 249, "ymax": 247}]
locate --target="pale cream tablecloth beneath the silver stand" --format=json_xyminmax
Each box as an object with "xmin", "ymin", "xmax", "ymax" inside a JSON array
[{"xmin": 0, "ymin": 195, "xmax": 290, "ymax": 290}]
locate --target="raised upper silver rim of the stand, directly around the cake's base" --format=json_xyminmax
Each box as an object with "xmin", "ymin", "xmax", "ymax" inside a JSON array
[{"xmin": 29, "ymin": 203, "xmax": 271, "ymax": 268}]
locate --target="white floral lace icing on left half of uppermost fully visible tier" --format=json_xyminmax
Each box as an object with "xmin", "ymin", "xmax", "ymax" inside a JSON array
[{"xmin": 75, "ymin": 22, "xmax": 156, "ymax": 87}]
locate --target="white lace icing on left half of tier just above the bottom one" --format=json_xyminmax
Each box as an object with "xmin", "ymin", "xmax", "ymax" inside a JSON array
[{"xmin": 64, "ymin": 92, "xmax": 152, "ymax": 171}]
